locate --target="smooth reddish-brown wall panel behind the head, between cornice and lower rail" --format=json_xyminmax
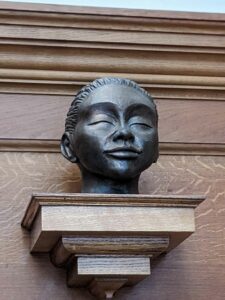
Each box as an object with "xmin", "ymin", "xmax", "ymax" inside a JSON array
[{"xmin": 0, "ymin": 94, "xmax": 225, "ymax": 144}]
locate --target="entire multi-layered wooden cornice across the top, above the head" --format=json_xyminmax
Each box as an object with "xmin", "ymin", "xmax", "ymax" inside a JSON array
[{"xmin": 0, "ymin": 2, "xmax": 225, "ymax": 100}]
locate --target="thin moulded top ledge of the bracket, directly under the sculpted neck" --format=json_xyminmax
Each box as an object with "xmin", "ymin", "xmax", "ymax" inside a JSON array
[{"xmin": 21, "ymin": 193, "xmax": 205, "ymax": 230}]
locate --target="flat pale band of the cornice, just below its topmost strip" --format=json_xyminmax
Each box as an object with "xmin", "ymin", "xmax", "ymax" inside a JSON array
[{"xmin": 0, "ymin": 24, "xmax": 225, "ymax": 48}]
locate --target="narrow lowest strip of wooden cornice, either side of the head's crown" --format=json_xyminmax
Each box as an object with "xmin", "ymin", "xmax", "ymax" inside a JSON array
[{"xmin": 0, "ymin": 81, "xmax": 225, "ymax": 101}]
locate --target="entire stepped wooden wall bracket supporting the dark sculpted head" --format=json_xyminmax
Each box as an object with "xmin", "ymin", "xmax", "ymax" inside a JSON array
[{"xmin": 22, "ymin": 194, "xmax": 204, "ymax": 299}]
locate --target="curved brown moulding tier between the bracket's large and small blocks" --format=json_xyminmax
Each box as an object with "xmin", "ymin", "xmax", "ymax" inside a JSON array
[{"xmin": 50, "ymin": 234, "xmax": 169, "ymax": 267}]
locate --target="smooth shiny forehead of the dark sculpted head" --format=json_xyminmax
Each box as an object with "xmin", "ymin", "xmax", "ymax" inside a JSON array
[{"xmin": 81, "ymin": 84, "xmax": 154, "ymax": 110}]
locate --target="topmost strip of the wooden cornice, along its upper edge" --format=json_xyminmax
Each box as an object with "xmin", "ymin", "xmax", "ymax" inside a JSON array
[{"xmin": 0, "ymin": 1, "xmax": 225, "ymax": 34}]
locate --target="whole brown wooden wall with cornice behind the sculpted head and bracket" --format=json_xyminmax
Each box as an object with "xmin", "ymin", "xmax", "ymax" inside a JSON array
[{"xmin": 0, "ymin": 1, "xmax": 225, "ymax": 300}]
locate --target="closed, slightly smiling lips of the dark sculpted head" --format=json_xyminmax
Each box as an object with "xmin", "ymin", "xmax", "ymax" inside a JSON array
[{"xmin": 104, "ymin": 147, "xmax": 142, "ymax": 159}]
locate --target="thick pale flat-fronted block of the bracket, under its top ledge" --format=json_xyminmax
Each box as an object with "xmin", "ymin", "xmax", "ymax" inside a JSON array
[{"xmin": 30, "ymin": 205, "xmax": 195, "ymax": 253}]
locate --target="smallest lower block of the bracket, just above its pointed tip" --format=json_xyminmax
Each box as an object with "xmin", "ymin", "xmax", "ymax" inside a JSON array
[{"xmin": 67, "ymin": 255, "xmax": 151, "ymax": 292}]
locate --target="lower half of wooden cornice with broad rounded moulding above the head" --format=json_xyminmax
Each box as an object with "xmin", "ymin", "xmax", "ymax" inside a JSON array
[{"xmin": 0, "ymin": 39, "xmax": 225, "ymax": 96}]
